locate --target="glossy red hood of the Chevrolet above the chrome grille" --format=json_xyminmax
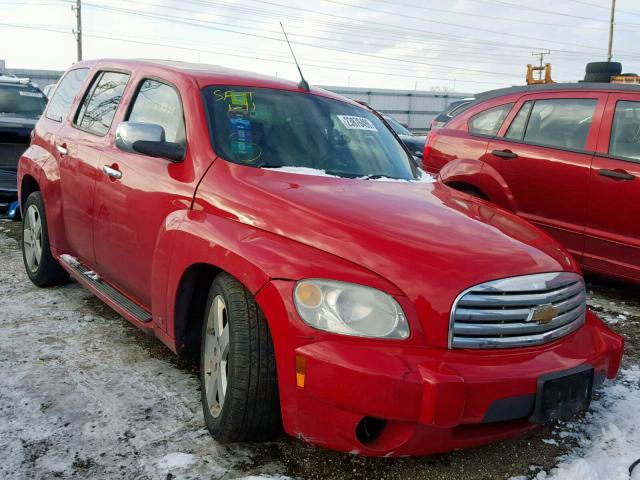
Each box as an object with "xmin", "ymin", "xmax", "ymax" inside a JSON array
[{"xmin": 198, "ymin": 159, "xmax": 579, "ymax": 344}]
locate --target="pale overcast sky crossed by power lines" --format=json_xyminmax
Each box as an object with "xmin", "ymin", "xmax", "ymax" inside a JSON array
[{"xmin": 0, "ymin": 0, "xmax": 640, "ymax": 92}]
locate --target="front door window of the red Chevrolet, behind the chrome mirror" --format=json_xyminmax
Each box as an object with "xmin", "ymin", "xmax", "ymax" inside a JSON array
[{"xmin": 127, "ymin": 79, "xmax": 186, "ymax": 145}]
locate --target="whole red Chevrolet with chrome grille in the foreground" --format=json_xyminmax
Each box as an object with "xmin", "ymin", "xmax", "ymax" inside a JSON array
[{"xmin": 19, "ymin": 60, "xmax": 623, "ymax": 455}]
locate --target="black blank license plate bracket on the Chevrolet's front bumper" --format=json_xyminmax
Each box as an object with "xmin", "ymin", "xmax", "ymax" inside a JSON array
[{"xmin": 529, "ymin": 365, "xmax": 594, "ymax": 423}]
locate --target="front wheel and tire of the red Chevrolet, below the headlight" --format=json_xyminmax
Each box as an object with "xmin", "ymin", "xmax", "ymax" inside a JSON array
[{"xmin": 200, "ymin": 273, "xmax": 281, "ymax": 442}]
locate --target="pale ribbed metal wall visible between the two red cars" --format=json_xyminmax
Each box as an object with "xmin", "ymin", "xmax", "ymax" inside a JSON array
[{"xmin": 322, "ymin": 87, "xmax": 473, "ymax": 133}]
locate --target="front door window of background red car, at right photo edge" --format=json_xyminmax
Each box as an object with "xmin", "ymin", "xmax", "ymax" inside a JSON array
[{"xmin": 609, "ymin": 101, "xmax": 640, "ymax": 160}]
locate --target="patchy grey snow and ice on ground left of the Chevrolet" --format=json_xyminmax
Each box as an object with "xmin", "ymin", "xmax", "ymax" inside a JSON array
[{"xmin": 0, "ymin": 234, "xmax": 288, "ymax": 479}]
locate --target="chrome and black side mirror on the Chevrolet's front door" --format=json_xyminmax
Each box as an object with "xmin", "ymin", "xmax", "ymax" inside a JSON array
[{"xmin": 116, "ymin": 122, "xmax": 185, "ymax": 163}]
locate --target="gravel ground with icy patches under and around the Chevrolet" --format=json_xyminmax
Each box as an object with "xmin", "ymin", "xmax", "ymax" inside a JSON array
[{"xmin": 0, "ymin": 219, "xmax": 640, "ymax": 480}]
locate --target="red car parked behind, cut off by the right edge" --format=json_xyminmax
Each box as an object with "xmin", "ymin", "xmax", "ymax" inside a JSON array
[{"xmin": 423, "ymin": 83, "xmax": 640, "ymax": 282}]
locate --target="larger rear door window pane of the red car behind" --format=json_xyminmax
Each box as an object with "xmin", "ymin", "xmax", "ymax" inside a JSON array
[{"xmin": 524, "ymin": 98, "xmax": 597, "ymax": 150}]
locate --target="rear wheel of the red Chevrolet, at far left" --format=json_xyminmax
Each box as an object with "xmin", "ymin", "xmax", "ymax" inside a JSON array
[{"xmin": 22, "ymin": 192, "xmax": 69, "ymax": 287}]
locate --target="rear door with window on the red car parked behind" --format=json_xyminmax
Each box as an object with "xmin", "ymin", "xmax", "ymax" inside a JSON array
[{"xmin": 483, "ymin": 92, "xmax": 606, "ymax": 260}]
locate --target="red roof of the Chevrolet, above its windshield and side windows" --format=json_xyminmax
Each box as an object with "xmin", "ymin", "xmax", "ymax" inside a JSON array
[{"xmin": 72, "ymin": 59, "xmax": 360, "ymax": 106}]
